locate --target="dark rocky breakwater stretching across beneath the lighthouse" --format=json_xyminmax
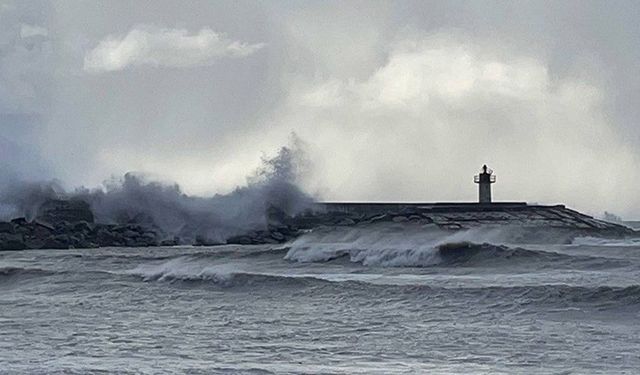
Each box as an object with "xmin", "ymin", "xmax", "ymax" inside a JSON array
[{"xmin": 0, "ymin": 200, "xmax": 638, "ymax": 250}]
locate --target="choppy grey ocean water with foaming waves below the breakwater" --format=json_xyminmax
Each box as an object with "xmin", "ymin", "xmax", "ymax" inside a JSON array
[{"xmin": 0, "ymin": 227, "xmax": 640, "ymax": 374}]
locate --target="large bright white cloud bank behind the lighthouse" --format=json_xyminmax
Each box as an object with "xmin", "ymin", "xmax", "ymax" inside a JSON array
[{"xmin": 272, "ymin": 36, "xmax": 640, "ymax": 214}]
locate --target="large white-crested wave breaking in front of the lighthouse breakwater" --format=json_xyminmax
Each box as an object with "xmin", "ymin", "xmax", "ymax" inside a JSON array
[{"xmin": 285, "ymin": 226, "xmax": 619, "ymax": 267}]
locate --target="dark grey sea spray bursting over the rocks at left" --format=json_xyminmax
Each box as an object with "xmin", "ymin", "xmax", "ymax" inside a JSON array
[{"xmin": 0, "ymin": 135, "xmax": 312, "ymax": 244}]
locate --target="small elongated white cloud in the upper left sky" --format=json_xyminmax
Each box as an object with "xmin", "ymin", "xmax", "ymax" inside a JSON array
[{"xmin": 84, "ymin": 26, "xmax": 264, "ymax": 72}]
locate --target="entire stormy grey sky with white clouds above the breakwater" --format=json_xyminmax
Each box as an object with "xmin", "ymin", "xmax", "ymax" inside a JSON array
[{"xmin": 0, "ymin": 0, "xmax": 640, "ymax": 219}]
